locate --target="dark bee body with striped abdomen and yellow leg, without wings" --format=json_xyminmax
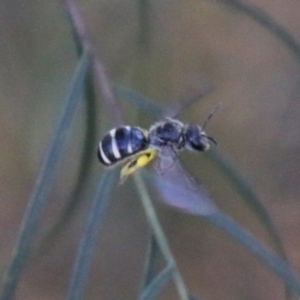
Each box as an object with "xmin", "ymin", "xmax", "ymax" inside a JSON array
[{"xmin": 97, "ymin": 113, "xmax": 216, "ymax": 182}]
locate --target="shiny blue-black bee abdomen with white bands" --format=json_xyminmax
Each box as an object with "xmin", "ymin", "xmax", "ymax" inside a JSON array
[{"xmin": 98, "ymin": 126, "xmax": 149, "ymax": 166}]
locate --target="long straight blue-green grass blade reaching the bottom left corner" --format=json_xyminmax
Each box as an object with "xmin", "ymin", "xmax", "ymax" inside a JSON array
[{"xmin": 0, "ymin": 54, "xmax": 89, "ymax": 300}]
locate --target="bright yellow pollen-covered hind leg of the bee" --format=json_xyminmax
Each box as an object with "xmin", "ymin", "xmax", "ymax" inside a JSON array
[{"xmin": 120, "ymin": 149, "xmax": 156, "ymax": 183}]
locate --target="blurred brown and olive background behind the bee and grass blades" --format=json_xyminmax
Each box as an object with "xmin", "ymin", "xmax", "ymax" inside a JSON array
[{"xmin": 0, "ymin": 0, "xmax": 300, "ymax": 300}]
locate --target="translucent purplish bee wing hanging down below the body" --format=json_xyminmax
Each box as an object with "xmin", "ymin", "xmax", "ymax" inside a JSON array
[{"xmin": 153, "ymin": 148, "xmax": 218, "ymax": 215}]
